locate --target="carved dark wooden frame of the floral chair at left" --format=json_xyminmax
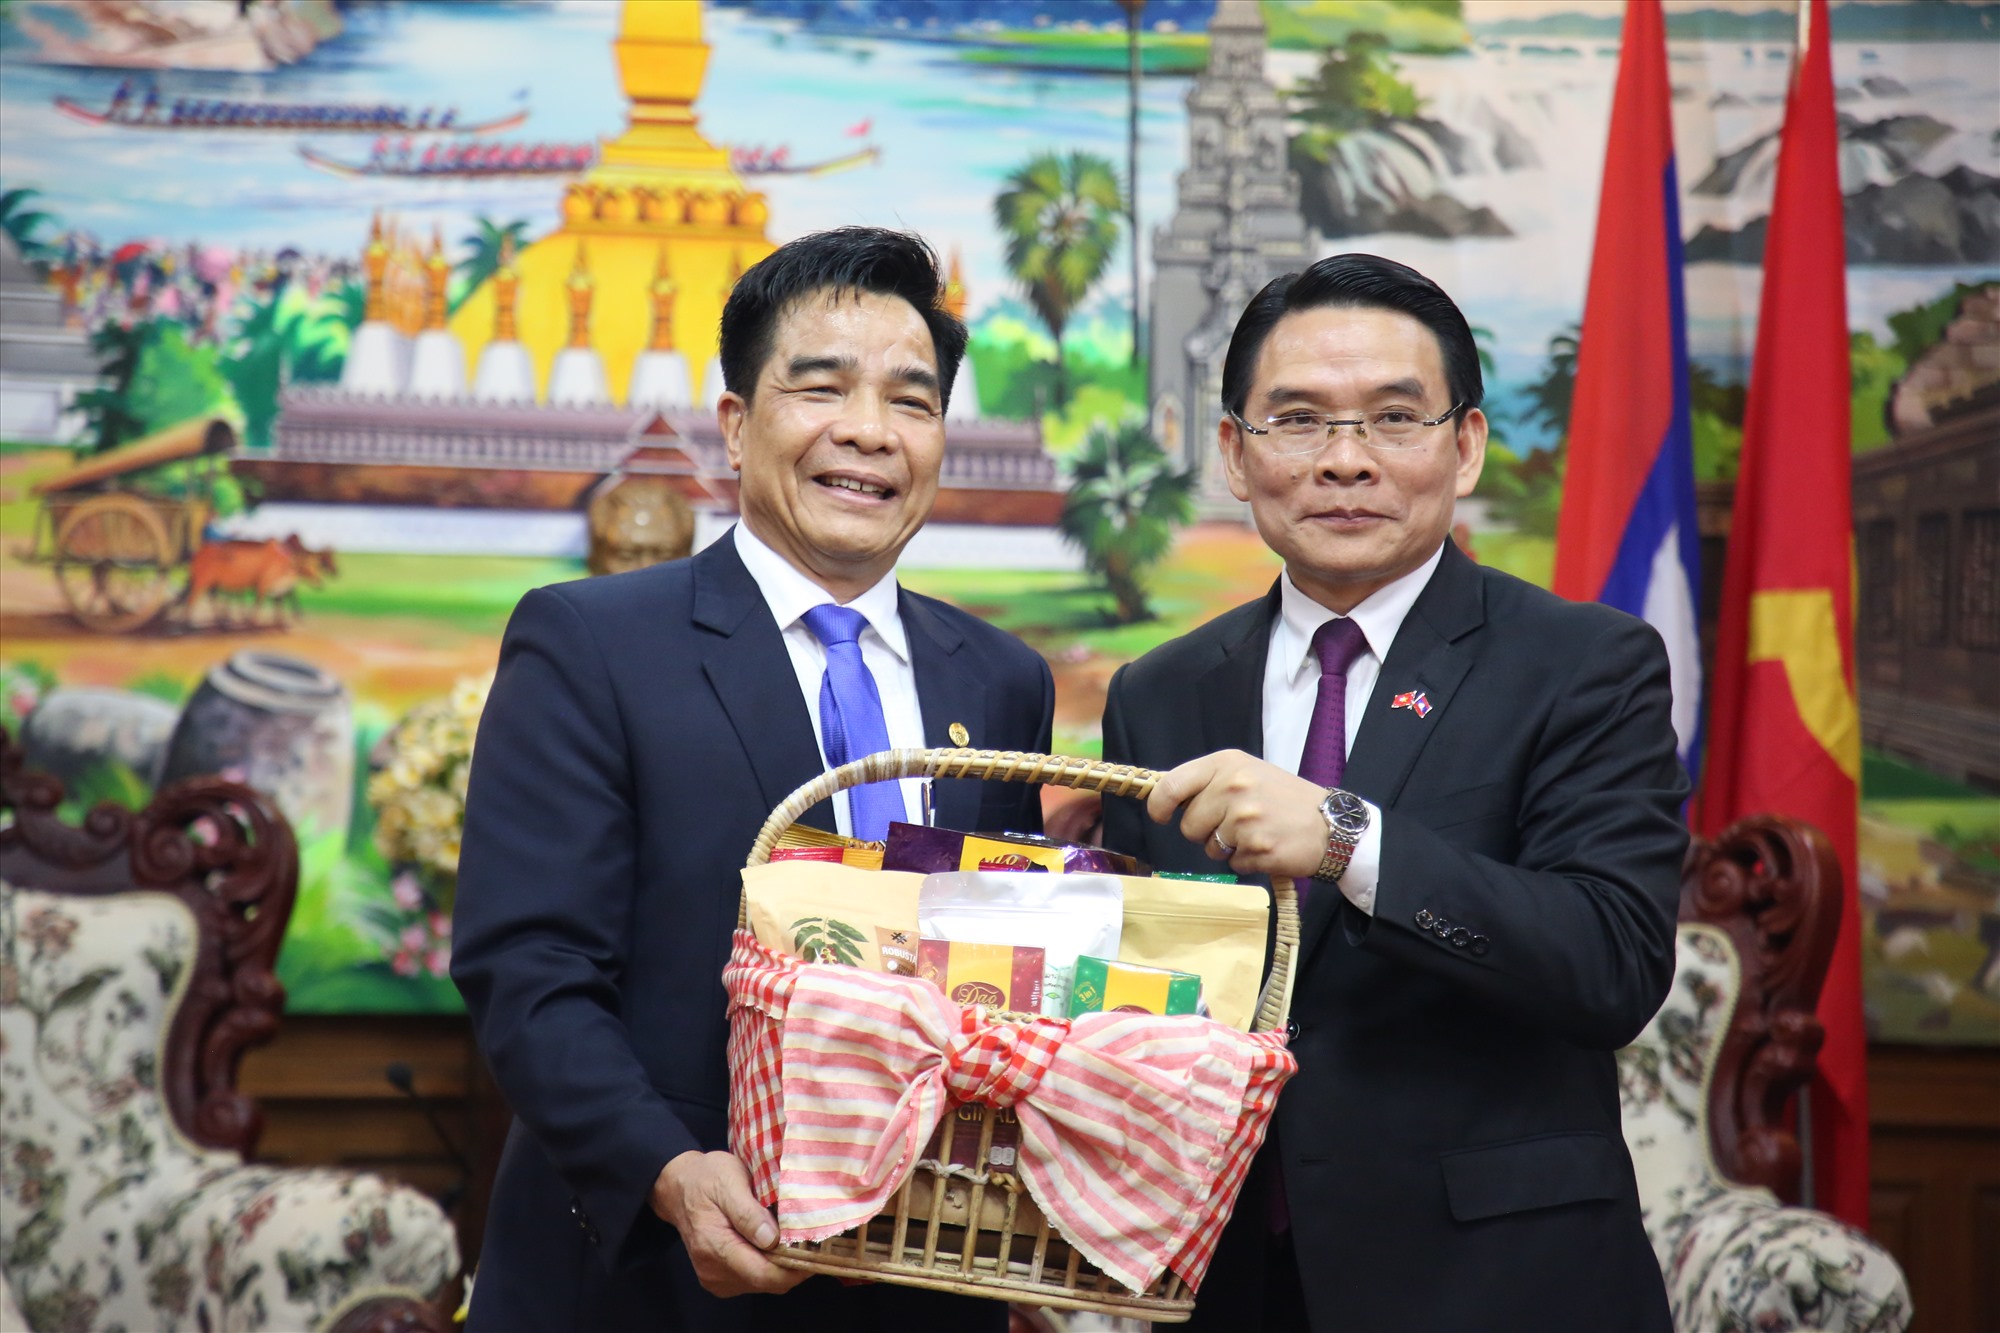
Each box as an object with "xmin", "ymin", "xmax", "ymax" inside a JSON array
[{"xmin": 0, "ymin": 731, "xmax": 452, "ymax": 1333}]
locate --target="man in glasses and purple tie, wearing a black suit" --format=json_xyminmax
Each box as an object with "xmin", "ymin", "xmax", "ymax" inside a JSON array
[{"xmin": 1104, "ymin": 254, "xmax": 1688, "ymax": 1333}]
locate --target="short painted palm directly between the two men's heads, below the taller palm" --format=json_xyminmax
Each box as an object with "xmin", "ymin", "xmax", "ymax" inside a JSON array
[{"xmin": 1058, "ymin": 418, "xmax": 1194, "ymax": 624}]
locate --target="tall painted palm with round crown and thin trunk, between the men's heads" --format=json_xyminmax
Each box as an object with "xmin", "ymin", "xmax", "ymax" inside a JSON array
[{"xmin": 994, "ymin": 152, "xmax": 1124, "ymax": 412}]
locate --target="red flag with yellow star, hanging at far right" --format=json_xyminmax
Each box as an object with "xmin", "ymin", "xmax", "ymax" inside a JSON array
[{"xmin": 1698, "ymin": 0, "xmax": 1868, "ymax": 1227}]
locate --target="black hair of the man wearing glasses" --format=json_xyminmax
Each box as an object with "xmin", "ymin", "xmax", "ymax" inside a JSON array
[{"xmin": 1222, "ymin": 254, "xmax": 1486, "ymax": 416}]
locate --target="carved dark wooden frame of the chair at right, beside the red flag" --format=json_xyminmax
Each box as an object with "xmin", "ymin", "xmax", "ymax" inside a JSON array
[{"xmin": 1680, "ymin": 815, "xmax": 1844, "ymax": 1203}]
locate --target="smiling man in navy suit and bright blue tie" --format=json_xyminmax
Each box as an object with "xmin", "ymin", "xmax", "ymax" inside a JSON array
[{"xmin": 452, "ymin": 228, "xmax": 1054, "ymax": 1333}]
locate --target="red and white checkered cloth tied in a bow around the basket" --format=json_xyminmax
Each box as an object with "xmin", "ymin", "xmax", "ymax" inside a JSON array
[{"xmin": 722, "ymin": 931, "xmax": 1298, "ymax": 1291}]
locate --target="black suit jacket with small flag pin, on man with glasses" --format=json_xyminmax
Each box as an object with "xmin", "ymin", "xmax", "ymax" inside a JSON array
[{"xmin": 1104, "ymin": 544, "xmax": 1688, "ymax": 1333}]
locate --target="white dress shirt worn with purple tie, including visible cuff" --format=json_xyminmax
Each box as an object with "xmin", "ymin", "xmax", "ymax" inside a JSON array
[{"xmin": 1264, "ymin": 546, "xmax": 1444, "ymax": 917}]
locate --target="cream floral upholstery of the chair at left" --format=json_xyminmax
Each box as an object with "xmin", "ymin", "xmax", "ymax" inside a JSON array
[{"xmin": 0, "ymin": 885, "xmax": 458, "ymax": 1329}]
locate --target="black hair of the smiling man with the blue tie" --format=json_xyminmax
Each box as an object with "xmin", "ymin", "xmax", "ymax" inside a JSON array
[{"xmin": 718, "ymin": 226, "xmax": 966, "ymax": 408}]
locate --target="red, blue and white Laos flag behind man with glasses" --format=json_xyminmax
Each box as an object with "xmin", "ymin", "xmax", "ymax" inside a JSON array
[{"xmin": 1556, "ymin": 0, "xmax": 1702, "ymax": 777}]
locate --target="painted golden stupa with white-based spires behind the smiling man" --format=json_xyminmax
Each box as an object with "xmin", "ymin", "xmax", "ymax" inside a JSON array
[{"xmin": 232, "ymin": 0, "xmax": 1062, "ymax": 526}]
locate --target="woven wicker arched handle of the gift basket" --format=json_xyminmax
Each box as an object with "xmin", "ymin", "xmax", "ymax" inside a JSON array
[{"xmin": 736, "ymin": 751, "xmax": 1298, "ymax": 1033}]
